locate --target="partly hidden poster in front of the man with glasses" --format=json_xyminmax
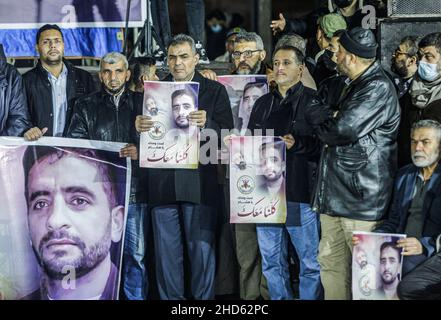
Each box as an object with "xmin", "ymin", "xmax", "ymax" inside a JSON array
[{"xmin": 217, "ymin": 75, "xmax": 268, "ymax": 133}]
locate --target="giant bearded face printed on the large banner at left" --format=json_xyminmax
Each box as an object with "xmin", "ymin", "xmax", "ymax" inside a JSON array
[{"xmin": 27, "ymin": 155, "xmax": 124, "ymax": 279}]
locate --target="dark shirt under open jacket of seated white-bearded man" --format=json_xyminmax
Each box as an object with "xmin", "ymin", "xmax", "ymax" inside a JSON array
[{"xmin": 404, "ymin": 172, "xmax": 429, "ymax": 238}]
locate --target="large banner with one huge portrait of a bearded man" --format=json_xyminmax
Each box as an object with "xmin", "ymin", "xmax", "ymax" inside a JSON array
[{"xmin": 0, "ymin": 137, "xmax": 131, "ymax": 300}]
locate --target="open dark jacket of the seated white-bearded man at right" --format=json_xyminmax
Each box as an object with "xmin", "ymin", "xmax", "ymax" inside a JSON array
[{"xmin": 375, "ymin": 164, "xmax": 441, "ymax": 256}]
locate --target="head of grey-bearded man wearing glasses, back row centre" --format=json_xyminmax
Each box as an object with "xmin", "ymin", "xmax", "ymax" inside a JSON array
[{"xmin": 231, "ymin": 32, "xmax": 266, "ymax": 75}]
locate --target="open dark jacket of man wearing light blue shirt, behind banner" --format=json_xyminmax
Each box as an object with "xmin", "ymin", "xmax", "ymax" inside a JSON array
[{"xmin": 23, "ymin": 60, "xmax": 96, "ymax": 136}]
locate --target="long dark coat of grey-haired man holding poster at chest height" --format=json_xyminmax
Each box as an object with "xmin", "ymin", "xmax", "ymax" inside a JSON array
[{"xmin": 149, "ymin": 71, "xmax": 234, "ymax": 206}]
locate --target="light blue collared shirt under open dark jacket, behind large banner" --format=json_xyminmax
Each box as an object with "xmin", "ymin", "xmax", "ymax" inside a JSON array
[{"xmin": 46, "ymin": 63, "xmax": 68, "ymax": 137}]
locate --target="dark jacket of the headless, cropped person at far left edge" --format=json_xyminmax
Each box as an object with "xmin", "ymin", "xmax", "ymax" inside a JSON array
[{"xmin": 0, "ymin": 45, "xmax": 31, "ymax": 136}]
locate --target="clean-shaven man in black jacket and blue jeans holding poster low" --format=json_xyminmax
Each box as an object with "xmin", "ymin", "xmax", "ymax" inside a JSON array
[{"xmin": 246, "ymin": 46, "xmax": 321, "ymax": 300}]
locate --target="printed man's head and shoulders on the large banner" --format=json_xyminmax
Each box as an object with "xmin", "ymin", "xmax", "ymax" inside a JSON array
[{"xmin": 23, "ymin": 147, "xmax": 124, "ymax": 300}]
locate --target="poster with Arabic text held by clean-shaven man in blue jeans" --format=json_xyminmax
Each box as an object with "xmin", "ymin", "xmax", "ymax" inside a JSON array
[{"xmin": 230, "ymin": 136, "xmax": 286, "ymax": 223}]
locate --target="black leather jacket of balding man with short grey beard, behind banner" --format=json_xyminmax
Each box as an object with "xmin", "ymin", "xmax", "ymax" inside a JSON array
[{"xmin": 66, "ymin": 89, "xmax": 142, "ymax": 143}]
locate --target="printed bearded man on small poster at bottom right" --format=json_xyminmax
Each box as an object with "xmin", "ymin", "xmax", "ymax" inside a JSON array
[{"xmin": 372, "ymin": 242, "xmax": 401, "ymax": 300}]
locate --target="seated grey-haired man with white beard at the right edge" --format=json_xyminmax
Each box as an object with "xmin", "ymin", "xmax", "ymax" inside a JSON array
[{"xmin": 353, "ymin": 120, "xmax": 441, "ymax": 276}]
